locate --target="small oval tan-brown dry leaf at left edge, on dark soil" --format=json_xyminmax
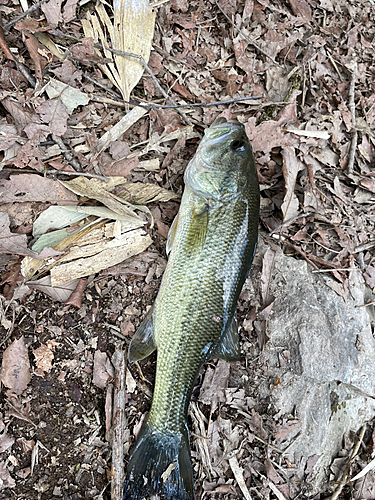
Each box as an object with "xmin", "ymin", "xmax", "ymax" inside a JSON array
[{"xmin": 0, "ymin": 337, "xmax": 31, "ymax": 395}]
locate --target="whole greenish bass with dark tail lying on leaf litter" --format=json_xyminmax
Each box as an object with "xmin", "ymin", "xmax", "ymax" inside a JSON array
[{"xmin": 123, "ymin": 117, "xmax": 260, "ymax": 500}]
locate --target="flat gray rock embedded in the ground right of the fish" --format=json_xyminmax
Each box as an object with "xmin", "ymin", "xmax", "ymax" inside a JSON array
[{"xmin": 264, "ymin": 252, "xmax": 375, "ymax": 494}]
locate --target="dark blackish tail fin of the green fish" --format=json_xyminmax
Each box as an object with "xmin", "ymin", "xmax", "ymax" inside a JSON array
[{"xmin": 124, "ymin": 422, "xmax": 194, "ymax": 500}]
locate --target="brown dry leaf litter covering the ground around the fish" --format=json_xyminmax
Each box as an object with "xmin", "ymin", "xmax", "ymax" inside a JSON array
[{"xmin": 0, "ymin": 0, "xmax": 375, "ymax": 500}]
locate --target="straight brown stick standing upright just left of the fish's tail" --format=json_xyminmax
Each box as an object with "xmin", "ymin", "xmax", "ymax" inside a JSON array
[{"xmin": 111, "ymin": 349, "xmax": 126, "ymax": 500}]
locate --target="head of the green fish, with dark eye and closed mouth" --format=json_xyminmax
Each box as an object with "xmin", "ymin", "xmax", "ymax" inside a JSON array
[{"xmin": 185, "ymin": 117, "xmax": 258, "ymax": 201}]
